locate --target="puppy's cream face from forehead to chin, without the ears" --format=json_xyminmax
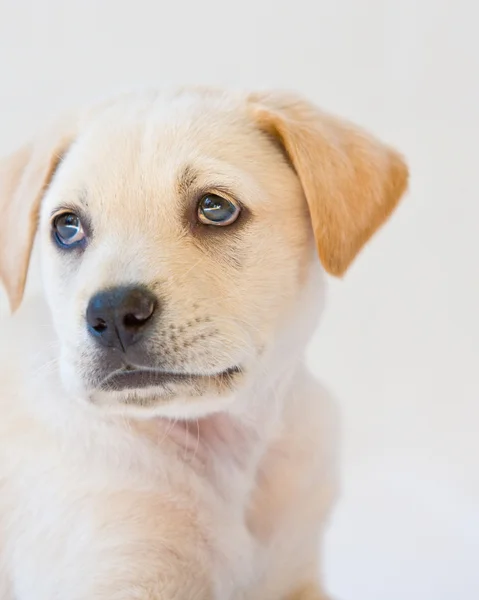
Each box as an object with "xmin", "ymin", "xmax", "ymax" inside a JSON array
[{"xmin": 41, "ymin": 98, "xmax": 313, "ymax": 414}]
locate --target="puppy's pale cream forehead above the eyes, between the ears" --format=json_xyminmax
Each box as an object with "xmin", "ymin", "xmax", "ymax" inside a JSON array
[{"xmin": 47, "ymin": 89, "xmax": 281, "ymax": 213}]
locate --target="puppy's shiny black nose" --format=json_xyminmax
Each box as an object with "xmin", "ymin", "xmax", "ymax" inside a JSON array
[{"xmin": 86, "ymin": 287, "xmax": 157, "ymax": 352}]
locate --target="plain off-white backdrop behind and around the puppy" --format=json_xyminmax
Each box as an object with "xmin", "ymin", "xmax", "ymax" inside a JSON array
[{"xmin": 0, "ymin": 0, "xmax": 479, "ymax": 600}]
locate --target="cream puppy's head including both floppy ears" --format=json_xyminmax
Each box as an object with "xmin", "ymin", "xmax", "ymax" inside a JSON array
[{"xmin": 0, "ymin": 90, "xmax": 407, "ymax": 416}]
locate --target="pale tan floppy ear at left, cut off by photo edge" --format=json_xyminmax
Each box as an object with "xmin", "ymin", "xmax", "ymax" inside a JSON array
[{"xmin": 0, "ymin": 131, "xmax": 71, "ymax": 311}]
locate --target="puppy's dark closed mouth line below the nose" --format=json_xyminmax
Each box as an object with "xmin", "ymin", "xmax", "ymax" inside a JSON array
[{"xmin": 100, "ymin": 367, "xmax": 242, "ymax": 392}]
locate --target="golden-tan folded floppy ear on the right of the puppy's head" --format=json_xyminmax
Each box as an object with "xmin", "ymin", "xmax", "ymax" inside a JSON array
[{"xmin": 249, "ymin": 93, "xmax": 408, "ymax": 276}]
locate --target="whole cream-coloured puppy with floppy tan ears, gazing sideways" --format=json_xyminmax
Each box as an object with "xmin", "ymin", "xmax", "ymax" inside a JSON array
[{"xmin": 0, "ymin": 89, "xmax": 407, "ymax": 600}]
